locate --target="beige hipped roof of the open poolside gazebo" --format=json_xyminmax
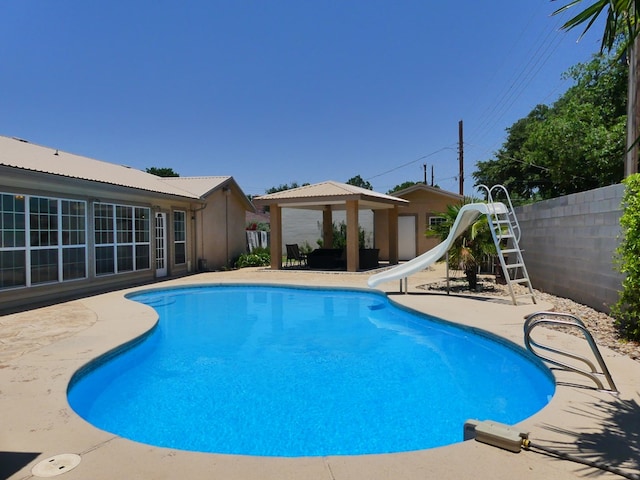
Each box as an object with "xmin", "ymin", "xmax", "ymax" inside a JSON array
[{"xmin": 253, "ymin": 180, "xmax": 409, "ymax": 210}]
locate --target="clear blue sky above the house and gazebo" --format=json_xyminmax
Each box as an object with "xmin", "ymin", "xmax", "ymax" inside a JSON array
[{"xmin": 0, "ymin": 0, "xmax": 602, "ymax": 194}]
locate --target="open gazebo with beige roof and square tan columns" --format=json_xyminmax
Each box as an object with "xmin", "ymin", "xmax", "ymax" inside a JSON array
[{"xmin": 253, "ymin": 181, "xmax": 409, "ymax": 272}]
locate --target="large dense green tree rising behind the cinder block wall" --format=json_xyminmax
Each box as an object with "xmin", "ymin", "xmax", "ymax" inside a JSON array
[{"xmin": 473, "ymin": 50, "xmax": 627, "ymax": 203}]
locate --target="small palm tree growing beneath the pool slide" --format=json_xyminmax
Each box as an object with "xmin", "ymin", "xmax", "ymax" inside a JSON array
[{"xmin": 426, "ymin": 202, "xmax": 496, "ymax": 290}]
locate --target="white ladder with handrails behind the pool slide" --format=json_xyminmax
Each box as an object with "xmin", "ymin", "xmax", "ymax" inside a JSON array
[{"xmin": 480, "ymin": 185, "xmax": 536, "ymax": 305}]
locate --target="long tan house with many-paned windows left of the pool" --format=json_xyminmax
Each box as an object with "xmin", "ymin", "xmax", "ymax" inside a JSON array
[{"xmin": 0, "ymin": 136, "xmax": 253, "ymax": 309}]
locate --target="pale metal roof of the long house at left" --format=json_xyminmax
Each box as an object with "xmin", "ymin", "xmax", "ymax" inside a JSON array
[{"xmin": 0, "ymin": 136, "xmax": 246, "ymax": 203}]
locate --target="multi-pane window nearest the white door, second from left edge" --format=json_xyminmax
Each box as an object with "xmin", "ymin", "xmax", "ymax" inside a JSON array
[{"xmin": 94, "ymin": 203, "xmax": 151, "ymax": 275}]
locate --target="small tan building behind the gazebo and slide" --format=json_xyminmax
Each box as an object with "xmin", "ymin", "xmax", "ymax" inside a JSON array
[{"xmin": 374, "ymin": 183, "xmax": 464, "ymax": 260}]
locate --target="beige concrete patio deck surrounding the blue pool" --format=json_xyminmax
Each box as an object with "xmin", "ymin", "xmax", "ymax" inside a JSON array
[{"xmin": 0, "ymin": 268, "xmax": 640, "ymax": 480}]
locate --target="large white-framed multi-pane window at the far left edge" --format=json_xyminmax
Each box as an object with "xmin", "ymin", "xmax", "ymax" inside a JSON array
[{"xmin": 0, "ymin": 193, "xmax": 87, "ymax": 288}]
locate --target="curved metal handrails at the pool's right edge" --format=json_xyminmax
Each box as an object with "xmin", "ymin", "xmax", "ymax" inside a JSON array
[{"xmin": 524, "ymin": 312, "xmax": 618, "ymax": 393}]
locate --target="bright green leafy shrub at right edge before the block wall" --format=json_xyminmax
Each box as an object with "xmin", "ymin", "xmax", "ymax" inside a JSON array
[{"xmin": 611, "ymin": 174, "xmax": 640, "ymax": 340}]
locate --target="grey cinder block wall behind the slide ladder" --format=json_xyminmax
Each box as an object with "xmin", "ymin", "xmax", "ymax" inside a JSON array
[{"xmin": 515, "ymin": 184, "xmax": 624, "ymax": 313}]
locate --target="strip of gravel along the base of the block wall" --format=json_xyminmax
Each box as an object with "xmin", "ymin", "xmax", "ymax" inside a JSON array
[{"xmin": 418, "ymin": 277, "xmax": 640, "ymax": 362}]
